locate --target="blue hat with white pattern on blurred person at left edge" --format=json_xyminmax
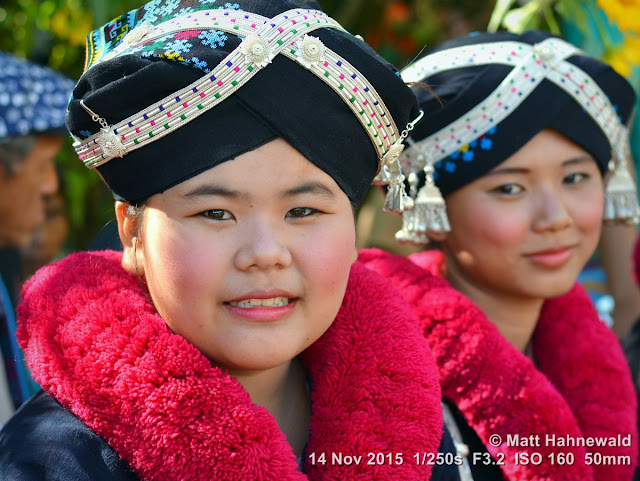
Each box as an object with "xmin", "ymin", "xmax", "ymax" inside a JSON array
[{"xmin": 0, "ymin": 52, "xmax": 74, "ymax": 140}]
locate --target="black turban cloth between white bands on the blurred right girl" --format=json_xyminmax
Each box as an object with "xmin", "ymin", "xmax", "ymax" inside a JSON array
[{"xmin": 403, "ymin": 30, "xmax": 635, "ymax": 196}]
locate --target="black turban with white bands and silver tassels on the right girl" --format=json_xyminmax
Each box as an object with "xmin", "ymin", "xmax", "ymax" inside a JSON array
[{"xmin": 396, "ymin": 32, "xmax": 638, "ymax": 244}]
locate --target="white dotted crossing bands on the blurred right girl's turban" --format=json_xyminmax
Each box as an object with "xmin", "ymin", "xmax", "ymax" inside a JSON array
[{"xmin": 400, "ymin": 38, "xmax": 626, "ymax": 173}]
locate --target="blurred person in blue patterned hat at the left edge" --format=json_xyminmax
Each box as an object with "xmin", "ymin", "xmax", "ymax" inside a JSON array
[{"xmin": 0, "ymin": 48, "xmax": 74, "ymax": 423}]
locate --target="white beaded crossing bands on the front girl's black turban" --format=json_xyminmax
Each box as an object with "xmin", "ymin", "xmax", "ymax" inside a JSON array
[{"xmin": 67, "ymin": 2, "xmax": 417, "ymax": 204}]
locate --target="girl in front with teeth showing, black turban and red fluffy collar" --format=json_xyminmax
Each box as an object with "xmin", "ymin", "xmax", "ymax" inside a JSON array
[{"xmin": 0, "ymin": 0, "xmax": 442, "ymax": 481}]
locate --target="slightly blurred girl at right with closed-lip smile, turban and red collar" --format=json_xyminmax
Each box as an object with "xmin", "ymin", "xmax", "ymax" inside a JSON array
[{"xmin": 361, "ymin": 31, "xmax": 637, "ymax": 481}]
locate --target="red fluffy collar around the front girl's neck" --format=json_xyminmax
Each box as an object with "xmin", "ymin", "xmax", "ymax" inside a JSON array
[{"xmin": 18, "ymin": 252, "xmax": 442, "ymax": 481}]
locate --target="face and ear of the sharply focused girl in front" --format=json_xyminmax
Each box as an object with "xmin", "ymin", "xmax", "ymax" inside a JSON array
[{"xmin": 118, "ymin": 139, "xmax": 356, "ymax": 370}]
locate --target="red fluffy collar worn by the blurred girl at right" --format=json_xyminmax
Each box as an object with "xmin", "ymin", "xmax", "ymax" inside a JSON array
[{"xmin": 360, "ymin": 250, "xmax": 638, "ymax": 481}]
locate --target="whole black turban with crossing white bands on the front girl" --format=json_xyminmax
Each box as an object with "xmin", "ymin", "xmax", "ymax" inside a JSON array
[{"xmin": 67, "ymin": 0, "xmax": 418, "ymax": 204}]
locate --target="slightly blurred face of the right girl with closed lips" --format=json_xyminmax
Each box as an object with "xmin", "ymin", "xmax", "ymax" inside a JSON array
[{"xmin": 443, "ymin": 129, "xmax": 604, "ymax": 299}]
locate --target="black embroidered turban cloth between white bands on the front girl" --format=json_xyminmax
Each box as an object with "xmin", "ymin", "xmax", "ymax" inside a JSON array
[{"xmin": 67, "ymin": 0, "xmax": 418, "ymax": 204}]
